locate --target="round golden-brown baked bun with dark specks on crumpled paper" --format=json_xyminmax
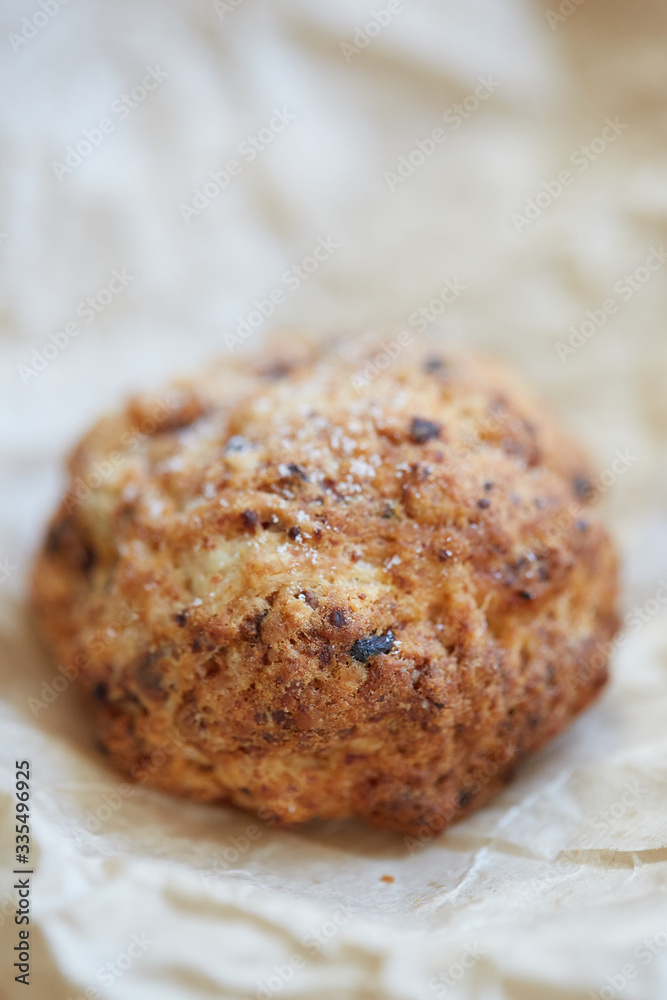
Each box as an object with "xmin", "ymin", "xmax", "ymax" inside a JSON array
[{"xmin": 33, "ymin": 340, "xmax": 617, "ymax": 834}]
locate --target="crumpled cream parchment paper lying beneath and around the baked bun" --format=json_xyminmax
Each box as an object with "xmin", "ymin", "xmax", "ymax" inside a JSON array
[{"xmin": 0, "ymin": 0, "xmax": 667, "ymax": 1000}]
